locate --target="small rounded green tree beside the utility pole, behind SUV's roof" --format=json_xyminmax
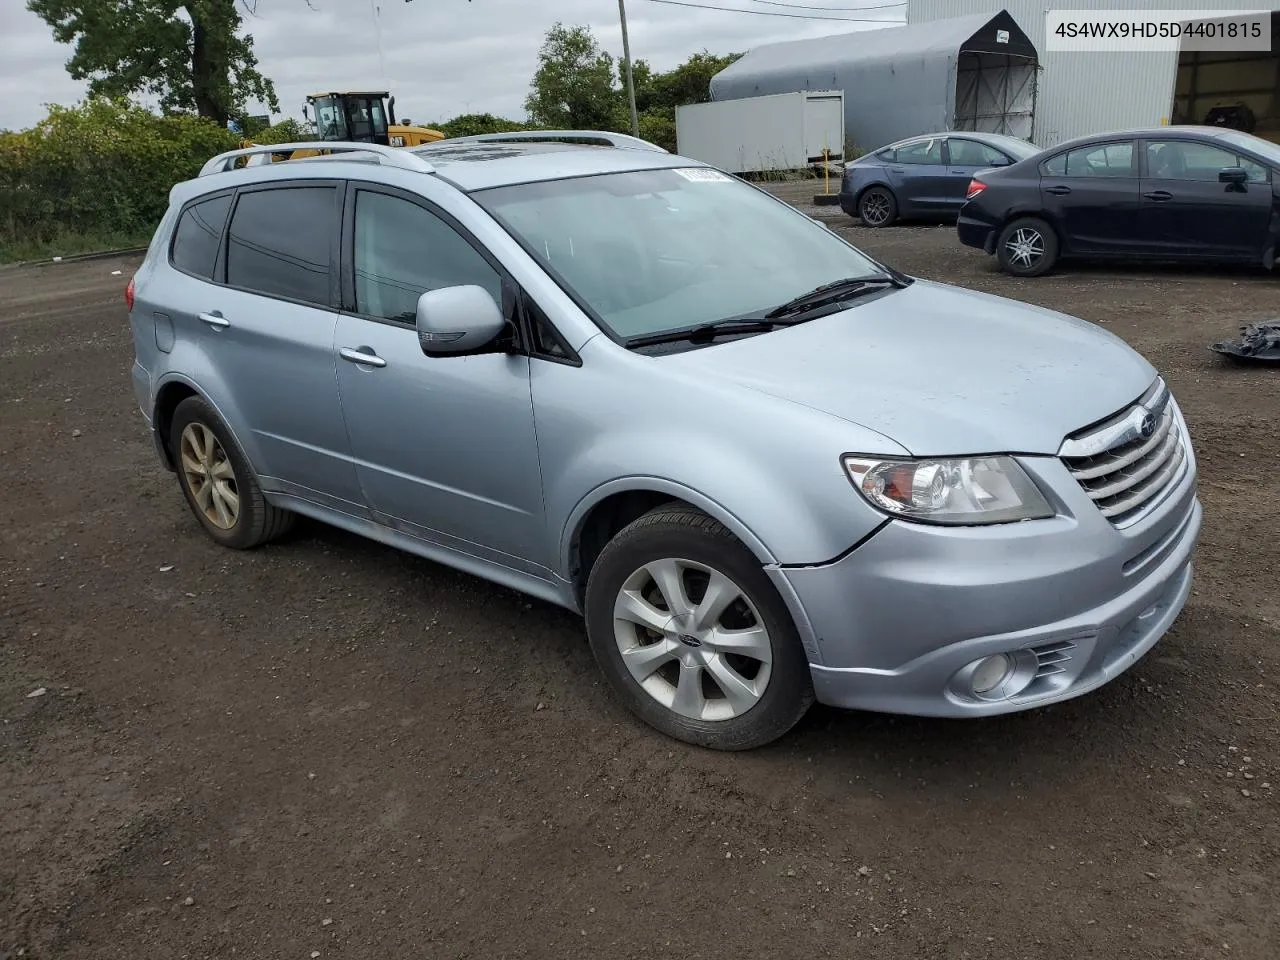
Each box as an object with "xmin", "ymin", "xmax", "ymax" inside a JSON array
[{"xmin": 525, "ymin": 22, "xmax": 622, "ymax": 129}]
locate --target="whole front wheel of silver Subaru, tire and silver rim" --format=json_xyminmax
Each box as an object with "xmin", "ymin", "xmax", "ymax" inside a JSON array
[{"xmin": 585, "ymin": 506, "xmax": 813, "ymax": 750}]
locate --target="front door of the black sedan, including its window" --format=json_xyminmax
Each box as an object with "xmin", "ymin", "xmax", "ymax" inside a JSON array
[{"xmin": 1142, "ymin": 138, "xmax": 1274, "ymax": 260}]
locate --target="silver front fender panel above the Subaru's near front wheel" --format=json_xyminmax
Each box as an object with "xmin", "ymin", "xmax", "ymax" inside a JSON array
[{"xmin": 532, "ymin": 343, "xmax": 906, "ymax": 580}]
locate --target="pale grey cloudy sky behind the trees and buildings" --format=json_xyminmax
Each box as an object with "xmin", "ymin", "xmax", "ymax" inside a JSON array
[{"xmin": 0, "ymin": 0, "xmax": 906, "ymax": 129}]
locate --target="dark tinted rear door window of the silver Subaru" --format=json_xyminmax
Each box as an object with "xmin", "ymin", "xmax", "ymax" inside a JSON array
[{"xmin": 227, "ymin": 187, "xmax": 334, "ymax": 306}]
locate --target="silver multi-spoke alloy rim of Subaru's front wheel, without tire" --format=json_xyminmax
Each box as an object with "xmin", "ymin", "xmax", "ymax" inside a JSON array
[{"xmin": 613, "ymin": 559, "xmax": 773, "ymax": 721}]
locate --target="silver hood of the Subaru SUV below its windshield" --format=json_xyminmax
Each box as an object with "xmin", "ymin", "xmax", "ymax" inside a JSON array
[{"xmin": 663, "ymin": 280, "xmax": 1156, "ymax": 457}]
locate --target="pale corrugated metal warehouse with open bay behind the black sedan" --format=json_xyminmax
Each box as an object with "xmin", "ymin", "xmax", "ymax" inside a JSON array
[{"xmin": 911, "ymin": 0, "xmax": 1280, "ymax": 146}]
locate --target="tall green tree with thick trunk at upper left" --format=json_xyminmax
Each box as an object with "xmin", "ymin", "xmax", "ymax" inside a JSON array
[{"xmin": 27, "ymin": 0, "xmax": 280, "ymax": 125}]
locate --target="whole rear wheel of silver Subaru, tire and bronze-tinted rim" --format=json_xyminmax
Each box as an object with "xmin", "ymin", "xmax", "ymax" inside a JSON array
[{"xmin": 169, "ymin": 397, "xmax": 296, "ymax": 550}]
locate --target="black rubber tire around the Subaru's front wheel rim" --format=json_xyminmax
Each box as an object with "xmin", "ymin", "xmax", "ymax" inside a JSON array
[{"xmin": 585, "ymin": 504, "xmax": 814, "ymax": 750}]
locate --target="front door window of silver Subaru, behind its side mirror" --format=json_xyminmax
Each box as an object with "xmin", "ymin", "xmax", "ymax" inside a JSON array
[{"xmin": 356, "ymin": 191, "xmax": 502, "ymax": 324}]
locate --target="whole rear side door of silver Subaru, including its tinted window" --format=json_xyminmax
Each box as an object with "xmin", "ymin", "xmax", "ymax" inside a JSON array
[{"xmin": 180, "ymin": 180, "xmax": 362, "ymax": 513}]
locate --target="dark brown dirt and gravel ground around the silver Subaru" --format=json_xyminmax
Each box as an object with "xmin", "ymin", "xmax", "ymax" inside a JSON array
[{"xmin": 0, "ymin": 204, "xmax": 1280, "ymax": 960}]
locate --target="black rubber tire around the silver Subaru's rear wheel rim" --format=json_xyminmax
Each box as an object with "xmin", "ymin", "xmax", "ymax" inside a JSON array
[{"xmin": 169, "ymin": 397, "xmax": 297, "ymax": 550}]
